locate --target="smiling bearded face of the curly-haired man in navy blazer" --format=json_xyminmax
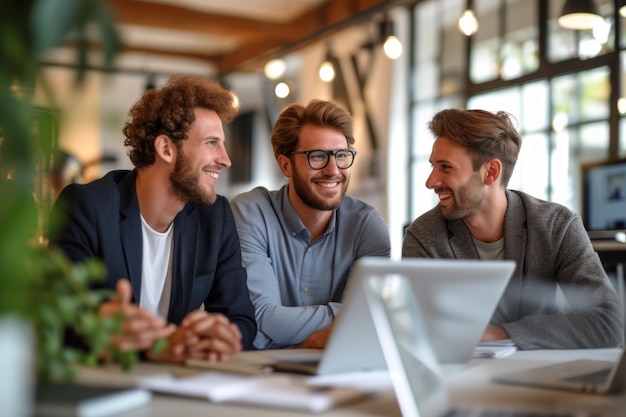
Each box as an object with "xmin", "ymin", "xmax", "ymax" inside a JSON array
[{"xmin": 170, "ymin": 108, "xmax": 231, "ymax": 204}]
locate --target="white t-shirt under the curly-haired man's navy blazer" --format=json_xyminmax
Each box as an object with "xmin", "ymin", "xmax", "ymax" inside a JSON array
[{"xmin": 139, "ymin": 216, "xmax": 174, "ymax": 318}]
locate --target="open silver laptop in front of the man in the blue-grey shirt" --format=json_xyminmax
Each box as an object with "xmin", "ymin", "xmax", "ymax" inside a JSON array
[{"xmin": 272, "ymin": 257, "xmax": 515, "ymax": 375}]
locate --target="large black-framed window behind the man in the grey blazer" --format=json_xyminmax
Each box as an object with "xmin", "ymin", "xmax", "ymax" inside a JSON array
[{"xmin": 409, "ymin": 0, "xmax": 626, "ymax": 219}]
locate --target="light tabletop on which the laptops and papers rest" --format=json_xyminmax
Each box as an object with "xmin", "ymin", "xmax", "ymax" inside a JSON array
[{"xmin": 73, "ymin": 349, "xmax": 626, "ymax": 417}]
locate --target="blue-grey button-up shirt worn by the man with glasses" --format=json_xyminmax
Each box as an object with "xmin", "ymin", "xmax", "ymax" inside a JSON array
[{"xmin": 231, "ymin": 185, "xmax": 391, "ymax": 349}]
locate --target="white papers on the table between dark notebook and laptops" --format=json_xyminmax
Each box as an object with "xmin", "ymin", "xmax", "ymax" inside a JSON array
[{"xmin": 139, "ymin": 372, "xmax": 368, "ymax": 413}]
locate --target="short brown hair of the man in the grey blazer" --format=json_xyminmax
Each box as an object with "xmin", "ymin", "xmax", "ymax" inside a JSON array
[{"xmin": 428, "ymin": 109, "xmax": 522, "ymax": 188}]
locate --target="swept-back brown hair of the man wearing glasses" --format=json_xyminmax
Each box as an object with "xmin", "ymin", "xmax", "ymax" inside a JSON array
[{"xmin": 272, "ymin": 100, "xmax": 354, "ymax": 158}]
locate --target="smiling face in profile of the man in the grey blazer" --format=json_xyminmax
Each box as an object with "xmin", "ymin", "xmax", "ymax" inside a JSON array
[{"xmin": 426, "ymin": 137, "xmax": 487, "ymax": 220}]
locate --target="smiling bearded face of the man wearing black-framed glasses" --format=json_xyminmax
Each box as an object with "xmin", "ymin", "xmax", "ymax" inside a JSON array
[{"xmin": 282, "ymin": 124, "xmax": 350, "ymax": 210}]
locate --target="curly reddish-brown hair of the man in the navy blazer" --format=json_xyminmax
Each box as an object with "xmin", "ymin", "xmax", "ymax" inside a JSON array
[{"xmin": 123, "ymin": 75, "xmax": 239, "ymax": 168}]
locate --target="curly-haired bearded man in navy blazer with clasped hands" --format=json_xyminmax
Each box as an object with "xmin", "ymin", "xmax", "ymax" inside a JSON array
[{"xmin": 51, "ymin": 76, "xmax": 256, "ymax": 362}]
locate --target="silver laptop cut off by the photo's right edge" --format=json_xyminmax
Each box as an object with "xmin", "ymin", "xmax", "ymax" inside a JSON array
[{"xmin": 493, "ymin": 350, "xmax": 626, "ymax": 394}]
